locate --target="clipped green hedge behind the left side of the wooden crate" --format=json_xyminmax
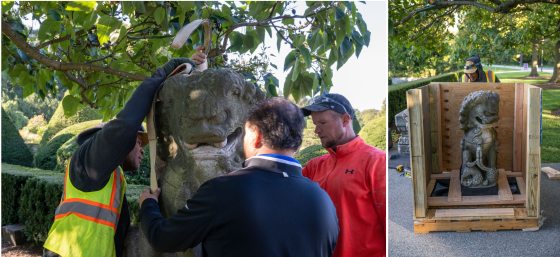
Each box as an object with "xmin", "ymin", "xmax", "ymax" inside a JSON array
[{"xmin": 387, "ymin": 72, "xmax": 462, "ymax": 127}]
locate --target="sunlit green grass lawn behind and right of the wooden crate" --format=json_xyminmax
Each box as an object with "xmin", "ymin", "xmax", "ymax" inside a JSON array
[{"xmin": 496, "ymin": 70, "xmax": 560, "ymax": 163}]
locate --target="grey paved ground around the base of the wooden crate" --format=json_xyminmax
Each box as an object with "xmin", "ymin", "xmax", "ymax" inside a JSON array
[{"xmin": 388, "ymin": 148, "xmax": 560, "ymax": 257}]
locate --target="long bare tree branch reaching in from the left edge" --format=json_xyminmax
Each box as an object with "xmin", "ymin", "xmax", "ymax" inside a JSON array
[{"xmin": 2, "ymin": 20, "xmax": 147, "ymax": 81}]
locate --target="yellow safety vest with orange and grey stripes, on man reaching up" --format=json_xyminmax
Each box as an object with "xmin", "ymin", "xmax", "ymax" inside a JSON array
[{"xmin": 44, "ymin": 165, "xmax": 126, "ymax": 257}]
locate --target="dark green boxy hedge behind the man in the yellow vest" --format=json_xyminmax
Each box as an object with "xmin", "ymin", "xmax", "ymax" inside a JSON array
[{"xmin": 2, "ymin": 163, "xmax": 147, "ymax": 243}]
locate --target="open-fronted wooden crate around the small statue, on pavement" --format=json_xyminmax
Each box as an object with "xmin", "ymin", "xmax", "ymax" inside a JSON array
[{"xmin": 407, "ymin": 83, "xmax": 541, "ymax": 233}]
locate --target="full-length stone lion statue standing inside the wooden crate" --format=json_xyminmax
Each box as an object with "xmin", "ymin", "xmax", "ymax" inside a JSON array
[{"xmin": 459, "ymin": 90, "xmax": 500, "ymax": 188}]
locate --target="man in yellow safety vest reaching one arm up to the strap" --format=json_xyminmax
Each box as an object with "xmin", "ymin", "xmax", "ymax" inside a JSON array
[{"xmin": 43, "ymin": 49, "xmax": 206, "ymax": 257}]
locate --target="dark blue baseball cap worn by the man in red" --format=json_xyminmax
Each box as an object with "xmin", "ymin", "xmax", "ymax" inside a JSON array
[{"xmin": 301, "ymin": 94, "xmax": 356, "ymax": 119}]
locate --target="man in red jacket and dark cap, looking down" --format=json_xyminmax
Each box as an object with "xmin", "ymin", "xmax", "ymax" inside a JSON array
[{"xmin": 302, "ymin": 94, "xmax": 386, "ymax": 257}]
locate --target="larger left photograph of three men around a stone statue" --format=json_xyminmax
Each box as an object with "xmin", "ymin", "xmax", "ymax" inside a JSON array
[{"xmin": 0, "ymin": 1, "xmax": 388, "ymax": 257}]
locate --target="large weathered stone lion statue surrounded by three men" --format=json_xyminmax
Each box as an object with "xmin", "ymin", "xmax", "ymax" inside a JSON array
[{"xmin": 127, "ymin": 69, "xmax": 265, "ymax": 257}]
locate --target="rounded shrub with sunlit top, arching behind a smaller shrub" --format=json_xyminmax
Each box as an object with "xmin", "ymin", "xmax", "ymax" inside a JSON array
[{"xmin": 33, "ymin": 120, "xmax": 101, "ymax": 171}]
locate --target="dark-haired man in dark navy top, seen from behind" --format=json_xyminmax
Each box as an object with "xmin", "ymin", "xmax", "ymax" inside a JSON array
[{"xmin": 140, "ymin": 98, "xmax": 338, "ymax": 257}]
